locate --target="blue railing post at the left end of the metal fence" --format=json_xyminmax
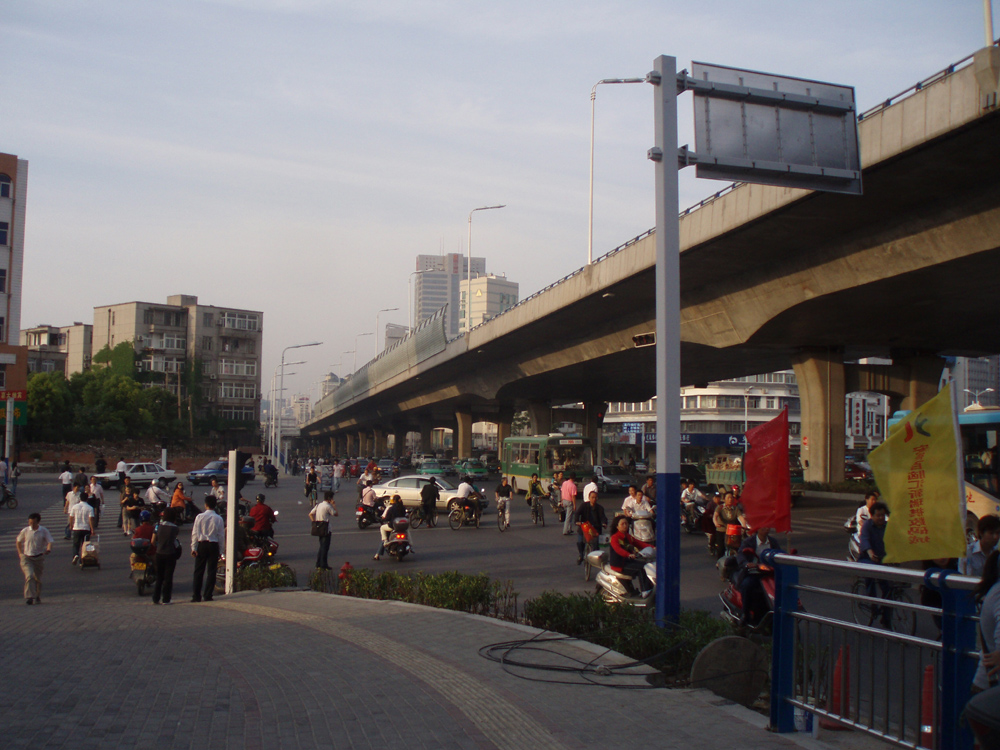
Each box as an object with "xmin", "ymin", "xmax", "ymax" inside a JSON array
[{"xmin": 761, "ymin": 550, "xmax": 799, "ymax": 732}]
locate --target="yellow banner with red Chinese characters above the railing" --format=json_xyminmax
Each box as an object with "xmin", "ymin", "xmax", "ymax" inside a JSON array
[{"xmin": 868, "ymin": 384, "xmax": 965, "ymax": 563}]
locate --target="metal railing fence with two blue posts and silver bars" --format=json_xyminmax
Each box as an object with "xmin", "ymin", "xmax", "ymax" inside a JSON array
[{"xmin": 762, "ymin": 550, "xmax": 979, "ymax": 750}]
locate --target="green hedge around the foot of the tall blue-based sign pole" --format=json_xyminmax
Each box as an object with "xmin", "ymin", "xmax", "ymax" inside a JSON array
[{"xmin": 524, "ymin": 591, "xmax": 732, "ymax": 682}]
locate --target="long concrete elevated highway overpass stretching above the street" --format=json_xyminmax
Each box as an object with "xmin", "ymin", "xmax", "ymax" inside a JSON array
[{"xmin": 303, "ymin": 45, "xmax": 1000, "ymax": 480}]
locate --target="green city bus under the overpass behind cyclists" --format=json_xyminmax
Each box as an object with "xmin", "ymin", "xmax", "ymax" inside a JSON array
[{"xmin": 500, "ymin": 434, "xmax": 594, "ymax": 492}]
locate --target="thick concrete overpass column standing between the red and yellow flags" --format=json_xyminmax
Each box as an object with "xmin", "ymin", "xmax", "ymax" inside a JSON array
[{"xmin": 792, "ymin": 349, "xmax": 847, "ymax": 482}]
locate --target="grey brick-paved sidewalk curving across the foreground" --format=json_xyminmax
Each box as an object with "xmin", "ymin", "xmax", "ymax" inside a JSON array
[{"xmin": 0, "ymin": 591, "xmax": 872, "ymax": 750}]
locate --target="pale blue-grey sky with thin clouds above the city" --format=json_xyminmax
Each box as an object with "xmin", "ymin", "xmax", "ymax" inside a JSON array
[{"xmin": 0, "ymin": 0, "xmax": 985, "ymax": 406}]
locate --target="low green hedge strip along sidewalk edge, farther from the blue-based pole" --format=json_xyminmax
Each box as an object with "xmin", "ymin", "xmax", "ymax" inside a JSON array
[{"xmin": 309, "ymin": 568, "xmax": 517, "ymax": 621}]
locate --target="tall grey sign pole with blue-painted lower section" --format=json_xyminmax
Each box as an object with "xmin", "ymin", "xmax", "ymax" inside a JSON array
[{"xmin": 647, "ymin": 55, "xmax": 681, "ymax": 626}]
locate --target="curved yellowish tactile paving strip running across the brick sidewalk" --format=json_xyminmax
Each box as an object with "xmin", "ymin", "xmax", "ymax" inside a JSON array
[{"xmin": 218, "ymin": 602, "xmax": 566, "ymax": 750}]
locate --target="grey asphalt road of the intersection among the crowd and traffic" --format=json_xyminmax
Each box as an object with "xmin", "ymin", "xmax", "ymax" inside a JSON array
[{"xmin": 0, "ymin": 475, "xmax": 876, "ymax": 614}]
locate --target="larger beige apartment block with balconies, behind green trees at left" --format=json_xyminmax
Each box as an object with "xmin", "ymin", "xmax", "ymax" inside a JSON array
[{"xmin": 93, "ymin": 294, "xmax": 264, "ymax": 422}]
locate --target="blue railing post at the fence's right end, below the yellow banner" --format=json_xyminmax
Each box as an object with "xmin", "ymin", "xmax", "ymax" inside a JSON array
[{"xmin": 924, "ymin": 569, "xmax": 977, "ymax": 750}]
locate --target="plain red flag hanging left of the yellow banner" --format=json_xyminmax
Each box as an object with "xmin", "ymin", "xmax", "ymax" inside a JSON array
[{"xmin": 740, "ymin": 407, "xmax": 792, "ymax": 531}]
